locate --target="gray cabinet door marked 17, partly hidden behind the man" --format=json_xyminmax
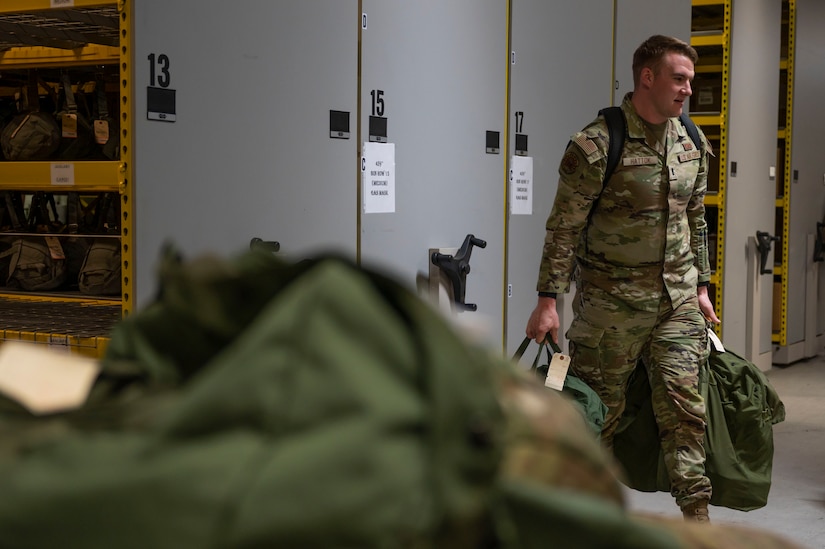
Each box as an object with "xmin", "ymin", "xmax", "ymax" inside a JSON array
[{"xmin": 507, "ymin": 0, "xmax": 613, "ymax": 355}]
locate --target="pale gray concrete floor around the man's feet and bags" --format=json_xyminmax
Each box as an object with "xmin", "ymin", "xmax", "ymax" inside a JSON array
[{"xmin": 627, "ymin": 355, "xmax": 825, "ymax": 549}]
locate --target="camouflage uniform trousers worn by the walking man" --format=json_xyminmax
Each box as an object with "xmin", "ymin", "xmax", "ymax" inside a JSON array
[{"xmin": 567, "ymin": 284, "xmax": 711, "ymax": 507}]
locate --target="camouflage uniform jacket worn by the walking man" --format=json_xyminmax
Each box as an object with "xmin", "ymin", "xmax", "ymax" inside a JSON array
[{"xmin": 537, "ymin": 94, "xmax": 710, "ymax": 311}]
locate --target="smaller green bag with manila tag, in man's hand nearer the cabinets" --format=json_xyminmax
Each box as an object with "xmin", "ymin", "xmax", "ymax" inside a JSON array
[{"xmin": 513, "ymin": 337, "xmax": 607, "ymax": 436}]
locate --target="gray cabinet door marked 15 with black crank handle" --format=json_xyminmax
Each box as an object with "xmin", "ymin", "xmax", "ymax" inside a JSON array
[{"xmin": 360, "ymin": 0, "xmax": 508, "ymax": 346}]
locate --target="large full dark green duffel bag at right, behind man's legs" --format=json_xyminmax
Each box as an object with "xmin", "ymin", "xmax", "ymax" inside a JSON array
[{"xmin": 613, "ymin": 336, "xmax": 785, "ymax": 511}]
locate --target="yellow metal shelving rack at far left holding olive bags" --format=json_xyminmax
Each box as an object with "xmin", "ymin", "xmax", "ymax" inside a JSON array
[{"xmin": 0, "ymin": 0, "xmax": 133, "ymax": 357}]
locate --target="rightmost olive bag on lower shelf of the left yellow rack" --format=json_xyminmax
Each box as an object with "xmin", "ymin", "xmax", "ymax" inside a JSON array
[{"xmin": 77, "ymin": 193, "xmax": 122, "ymax": 296}]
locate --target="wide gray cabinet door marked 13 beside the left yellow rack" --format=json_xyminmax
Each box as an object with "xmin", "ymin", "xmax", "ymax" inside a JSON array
[{"xmin": 133, "ymin": 0, "xmax": 359, "ymax": 302}]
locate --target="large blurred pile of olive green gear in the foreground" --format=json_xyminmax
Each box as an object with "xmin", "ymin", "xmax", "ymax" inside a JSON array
[{"xmin": 0, "ymin": 246, "xmax": 804, "ymax": 549}]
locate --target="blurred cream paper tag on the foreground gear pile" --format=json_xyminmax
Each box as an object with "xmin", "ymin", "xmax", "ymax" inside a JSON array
[{"xmin": 0, "ymin": 341, "xmax": 100, "ymax": 414}]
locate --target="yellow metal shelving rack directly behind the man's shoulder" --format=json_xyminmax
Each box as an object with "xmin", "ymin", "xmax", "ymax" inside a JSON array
[{"xmin": 690, "ymin": 0, "xmax": 732, "ymax": 336}]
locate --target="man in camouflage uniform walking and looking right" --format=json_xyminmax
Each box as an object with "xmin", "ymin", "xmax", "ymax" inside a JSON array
[{"xmin": 526, "ymin": 36, "xmax": 719, "ymax": 521}]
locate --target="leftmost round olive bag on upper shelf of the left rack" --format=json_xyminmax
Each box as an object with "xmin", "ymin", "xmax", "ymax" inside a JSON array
[{"xmin": 0, "ymin": 70, "xmax": 60, "ymax": 160}]
